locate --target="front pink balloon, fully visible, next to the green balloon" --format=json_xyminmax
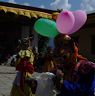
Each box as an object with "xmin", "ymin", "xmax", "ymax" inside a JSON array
[{"xmin": 56, "ymin": 11, "xmax": 75, "ymax": 35}]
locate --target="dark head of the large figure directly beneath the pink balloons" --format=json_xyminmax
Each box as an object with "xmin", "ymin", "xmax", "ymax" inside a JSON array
[{"xmin": 54, "ymin": 34, "xmax": 74, "ymax": 57}]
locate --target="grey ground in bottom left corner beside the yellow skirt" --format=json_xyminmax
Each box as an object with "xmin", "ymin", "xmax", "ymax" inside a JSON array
[{"xmin": 0, "ymin": 65, "xmax": 16, "ymax": 96}]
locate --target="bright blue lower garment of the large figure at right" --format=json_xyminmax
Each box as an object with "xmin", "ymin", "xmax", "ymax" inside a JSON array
[{"xmin": 57, "ymin": 79, "xmax": 95, "ymax": 96}]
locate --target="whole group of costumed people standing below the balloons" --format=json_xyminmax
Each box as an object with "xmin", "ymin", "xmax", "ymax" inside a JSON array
[{"xmin": 11, "ymin": 34, "xmax": 95, "ymax": 96}]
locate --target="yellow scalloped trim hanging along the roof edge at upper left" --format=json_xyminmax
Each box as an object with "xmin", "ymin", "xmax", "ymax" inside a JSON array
[{"xmin": 0, "ymin": 6, "xmax": 52, "ymax": 19}]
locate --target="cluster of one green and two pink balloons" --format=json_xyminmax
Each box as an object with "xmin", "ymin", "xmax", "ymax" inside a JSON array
[{"xmin": 34, "ymin": 10, "xmax": 87, "ymax": 38}]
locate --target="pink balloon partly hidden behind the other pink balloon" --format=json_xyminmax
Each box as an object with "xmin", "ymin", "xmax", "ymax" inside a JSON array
[{"xmin": 69, "ymin": 10, "xmax": 87, "ymax": 34}]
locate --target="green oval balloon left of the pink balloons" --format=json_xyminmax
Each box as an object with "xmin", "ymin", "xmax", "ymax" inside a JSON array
[{"xmin": 34, "ymin": 18, "xmax": 59, "ymax": 37}]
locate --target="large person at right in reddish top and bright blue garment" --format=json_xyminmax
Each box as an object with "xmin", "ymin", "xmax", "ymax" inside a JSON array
[{"xmin": 55, "ymin": 35, "xmax": 95, "ymax": 96}]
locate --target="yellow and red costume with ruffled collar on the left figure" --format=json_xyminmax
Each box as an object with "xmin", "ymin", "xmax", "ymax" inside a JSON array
[{"xmin": 11, "ymin": 50, "xmax": 34, "ymax": 96}]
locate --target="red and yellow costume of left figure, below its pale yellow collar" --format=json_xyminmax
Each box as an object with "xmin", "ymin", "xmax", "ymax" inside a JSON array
[{"xmin": 11, "ymin": 57, "xmax": 34, "ymax": 96}]
